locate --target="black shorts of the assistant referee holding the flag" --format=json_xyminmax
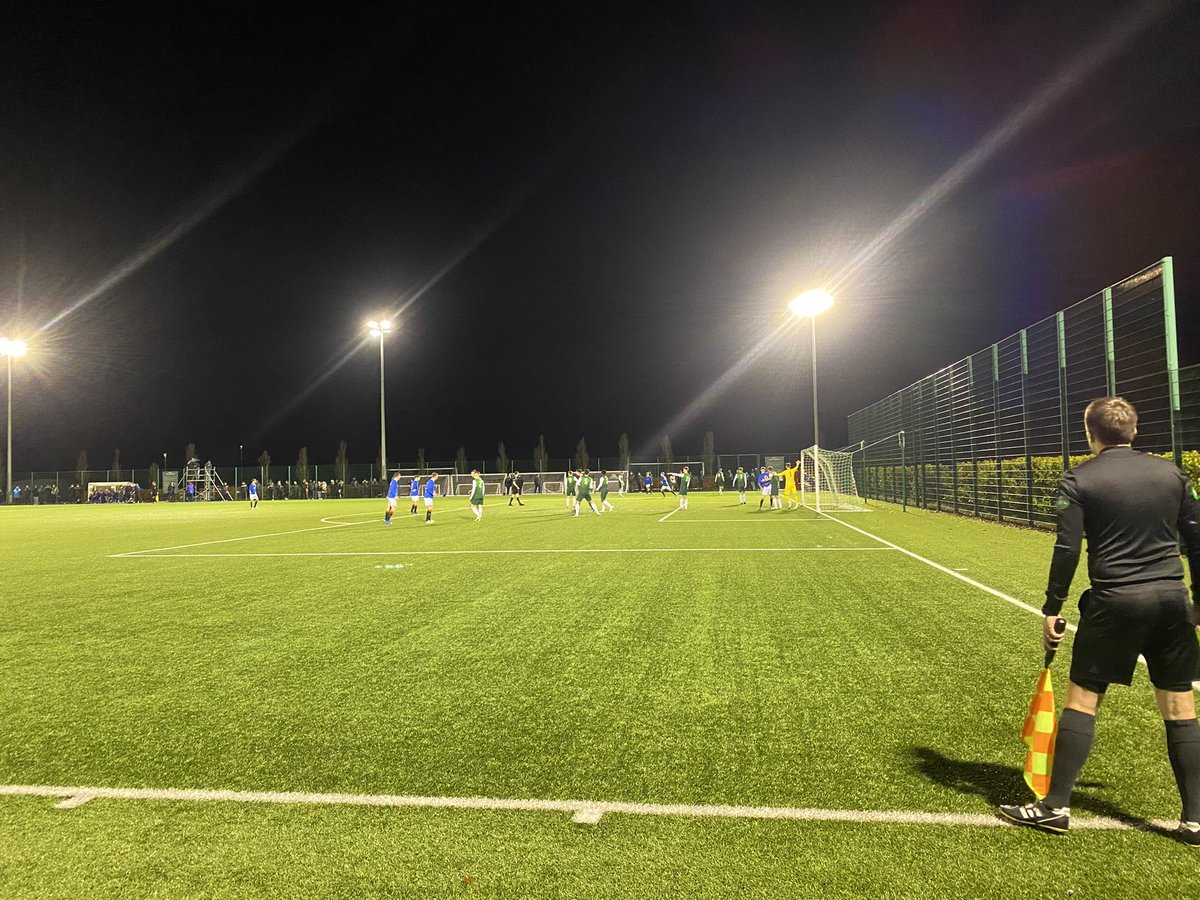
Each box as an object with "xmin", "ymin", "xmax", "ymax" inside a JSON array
[{"xmin": 1070, "ymin": 580, "xmax": 1200, "ymax": 694}]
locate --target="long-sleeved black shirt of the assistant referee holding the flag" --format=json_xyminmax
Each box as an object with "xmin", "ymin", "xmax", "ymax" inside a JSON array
[{"xmin": 1042, "ymin": 446, "xmax": 1200, "ymax": 616}]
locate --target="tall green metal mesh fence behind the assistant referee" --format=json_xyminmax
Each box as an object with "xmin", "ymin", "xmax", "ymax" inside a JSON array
[{"xmin": 848, "ymin": 257, "xmax": 1185, "ymax": 524}]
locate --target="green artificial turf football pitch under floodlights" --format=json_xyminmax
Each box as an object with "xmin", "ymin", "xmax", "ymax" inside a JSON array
[{"xmin": 0, "ymin": 493, "xmax": 1200, "ymax": 900}]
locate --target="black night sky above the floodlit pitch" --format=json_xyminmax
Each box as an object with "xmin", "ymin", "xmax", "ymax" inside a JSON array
[{"xmin": 0, "ymin": 0, "xmax": 1200, "ymax": 472}]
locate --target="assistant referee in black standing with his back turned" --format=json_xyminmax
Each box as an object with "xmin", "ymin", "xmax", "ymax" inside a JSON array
[{"xmin": 1000, "ymin": 397, "xmax": 1200, "ymax": 847}]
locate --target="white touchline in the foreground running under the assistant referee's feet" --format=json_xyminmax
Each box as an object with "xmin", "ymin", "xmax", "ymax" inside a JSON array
[{"xmin": 0, "ymin": 785, "xmax": 1175, "ymax": 830}]
